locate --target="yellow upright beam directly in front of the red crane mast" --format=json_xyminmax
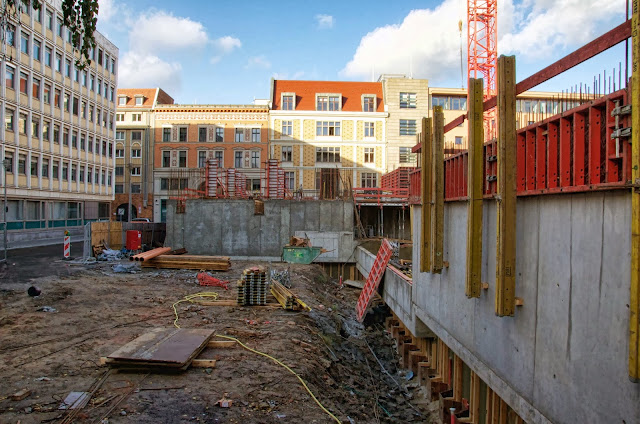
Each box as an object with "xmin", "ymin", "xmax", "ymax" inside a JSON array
[{"xmin": 465, "ymin": 78, "xmax": 484, "ymax": 297}]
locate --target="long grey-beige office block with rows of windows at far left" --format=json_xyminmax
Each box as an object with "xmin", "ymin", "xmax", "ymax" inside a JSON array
[{"xmin": 0, "ymin": 1, "xmax": 118, "ymax": 247}]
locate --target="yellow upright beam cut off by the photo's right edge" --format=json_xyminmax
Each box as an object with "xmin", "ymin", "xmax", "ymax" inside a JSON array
[{"xmin": 629, "ymin": 0, "xmax": 640, "ymax": 382}]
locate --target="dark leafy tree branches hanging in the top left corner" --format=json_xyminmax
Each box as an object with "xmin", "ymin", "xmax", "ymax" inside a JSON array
[{"xmin": 0, "ymin": 0, "xmax": 99, "ymax": 70}]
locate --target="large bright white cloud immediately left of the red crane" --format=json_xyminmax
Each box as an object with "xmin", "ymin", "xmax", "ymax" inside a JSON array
[{"xmin": 340, "ymin": 0, "xmax": 466, "ymax": 79}]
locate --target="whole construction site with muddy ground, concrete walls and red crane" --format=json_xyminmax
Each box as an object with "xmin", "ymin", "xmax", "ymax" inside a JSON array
[{"xmin": 0, "ymin": 0, "xmax": 640, "ymax": 424}]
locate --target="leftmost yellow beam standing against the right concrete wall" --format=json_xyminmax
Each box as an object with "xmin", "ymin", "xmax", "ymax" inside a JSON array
[{"xmin": 420, "ymin": 118, "xmax": 431, "ymax": 272}]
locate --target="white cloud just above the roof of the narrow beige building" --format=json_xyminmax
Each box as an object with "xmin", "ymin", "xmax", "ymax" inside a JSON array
[{"xmin": 118, "ymin": 52, "xmax": 182, "ymax": 93}]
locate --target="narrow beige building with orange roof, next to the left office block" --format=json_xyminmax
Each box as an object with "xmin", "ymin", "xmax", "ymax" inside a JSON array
[{"xmin": 112, "ymin": 88, "xmax": 173, "ymax": 221}]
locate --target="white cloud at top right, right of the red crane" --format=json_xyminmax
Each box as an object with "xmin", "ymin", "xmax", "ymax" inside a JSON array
[{"xmin": 498, "ymin": 0, "xmax": 625, "ymax": 59}]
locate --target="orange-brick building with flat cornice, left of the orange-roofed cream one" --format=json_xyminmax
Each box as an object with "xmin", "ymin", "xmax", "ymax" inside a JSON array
[{"xmin": 153, "ymin": 105, "xmax": 269, "ymax": 221}]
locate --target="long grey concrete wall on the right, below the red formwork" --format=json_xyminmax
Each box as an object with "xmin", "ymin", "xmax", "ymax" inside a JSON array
[{"xmin": 358, "ymin": 192, "xmax": 640, "ymax": 424}]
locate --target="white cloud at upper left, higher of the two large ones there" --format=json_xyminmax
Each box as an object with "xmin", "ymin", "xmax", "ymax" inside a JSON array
[{"xmin": 129, "ymin": 11, "xmax": 209, "ymax": 53}]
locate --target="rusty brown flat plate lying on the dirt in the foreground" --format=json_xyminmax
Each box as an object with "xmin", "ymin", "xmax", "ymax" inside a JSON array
[{"xmin": 107, "ymin": 328, "xmax": 214, "ymax": 368}]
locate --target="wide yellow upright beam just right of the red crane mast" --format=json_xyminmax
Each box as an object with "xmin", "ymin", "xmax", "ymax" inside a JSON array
[{"xmin": 495, "ymin": 56, "xmax": 516, "ymax": 316}]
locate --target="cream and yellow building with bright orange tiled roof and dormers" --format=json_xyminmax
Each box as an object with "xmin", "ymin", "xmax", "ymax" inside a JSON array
[{"xmin": 269, "ymin": 80, "xmax": 387, "ymax": 198}]
